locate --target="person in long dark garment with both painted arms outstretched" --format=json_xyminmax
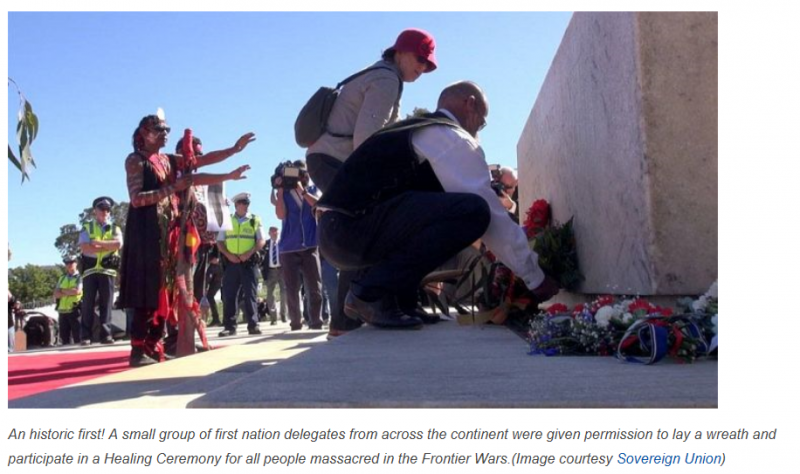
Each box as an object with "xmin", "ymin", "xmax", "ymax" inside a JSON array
[{"xmin": 120, "ymin": 115, "xmax": 255, "ymax": 367}]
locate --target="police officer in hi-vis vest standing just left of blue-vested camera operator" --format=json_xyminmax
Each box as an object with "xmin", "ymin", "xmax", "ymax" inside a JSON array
[{"xmin": 217, "ymin": 193, "xmax": 266, "ymax": 337}]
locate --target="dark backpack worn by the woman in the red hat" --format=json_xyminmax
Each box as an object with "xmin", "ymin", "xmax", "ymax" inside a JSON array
[{"xmin": 294, "ymin": 66, "xmax": 403, "ymax": 148}]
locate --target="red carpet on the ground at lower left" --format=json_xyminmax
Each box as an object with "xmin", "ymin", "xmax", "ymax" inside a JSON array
[{"xmin": 8, "ymin": 350, "xmax": 130, "ymax": 400}]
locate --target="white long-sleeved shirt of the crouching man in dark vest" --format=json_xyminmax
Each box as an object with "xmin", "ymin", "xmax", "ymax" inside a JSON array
[{"xmin": 411, "ymin": 109, "xmax": 544, "ymax": 289}]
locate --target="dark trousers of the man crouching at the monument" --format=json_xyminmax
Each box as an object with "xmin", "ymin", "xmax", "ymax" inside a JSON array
[{"xmin": 318, "ymin": 191, "xmax": 490, "ymax": 301}]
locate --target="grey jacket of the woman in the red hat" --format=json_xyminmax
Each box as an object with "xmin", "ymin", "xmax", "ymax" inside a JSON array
[{"xmin": 306, "ymin": 60, "xmax": 400, "ymax": 161}]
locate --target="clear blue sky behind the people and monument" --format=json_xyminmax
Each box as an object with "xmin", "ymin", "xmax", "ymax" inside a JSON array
[{"xmin": 8, "ymin": 12, "xmax": 571, "ymax": 266}]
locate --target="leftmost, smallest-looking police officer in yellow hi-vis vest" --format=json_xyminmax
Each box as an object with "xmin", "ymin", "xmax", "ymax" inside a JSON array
[{"xmin": 53, "ymin": 256, "xmax": 83, "ymax": 345}]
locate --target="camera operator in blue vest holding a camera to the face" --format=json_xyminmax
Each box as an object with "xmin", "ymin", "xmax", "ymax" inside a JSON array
[{"xmin": 271, "ymin": 160, "xmax": 322, "ymax": 331}]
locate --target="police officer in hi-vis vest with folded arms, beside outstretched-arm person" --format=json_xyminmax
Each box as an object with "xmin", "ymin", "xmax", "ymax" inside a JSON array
[{"xmin": 78, "ymin": 196, "xmax": 122, "ymax": 346}]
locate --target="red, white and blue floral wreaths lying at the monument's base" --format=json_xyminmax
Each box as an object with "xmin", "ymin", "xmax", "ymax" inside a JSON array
[{"xmin": 528, "ymin": 283, "xmax": 717, "ymax": 363}]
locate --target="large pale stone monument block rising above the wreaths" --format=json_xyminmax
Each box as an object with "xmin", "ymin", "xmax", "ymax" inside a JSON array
[{"xmin": 517, "ymin": 13, "xmax": 718, "ymax": 295}]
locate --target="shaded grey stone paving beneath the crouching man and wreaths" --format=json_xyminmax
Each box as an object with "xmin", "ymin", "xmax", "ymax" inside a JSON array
[{"xmin": 187, "ymin": 321, "xmax": 718, "ymax": 408}]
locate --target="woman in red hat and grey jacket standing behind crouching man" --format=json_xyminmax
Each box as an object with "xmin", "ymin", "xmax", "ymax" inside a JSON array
[{"xmin": 306, "ymin": 28, "xmax": 437, "ymax": 336}]
